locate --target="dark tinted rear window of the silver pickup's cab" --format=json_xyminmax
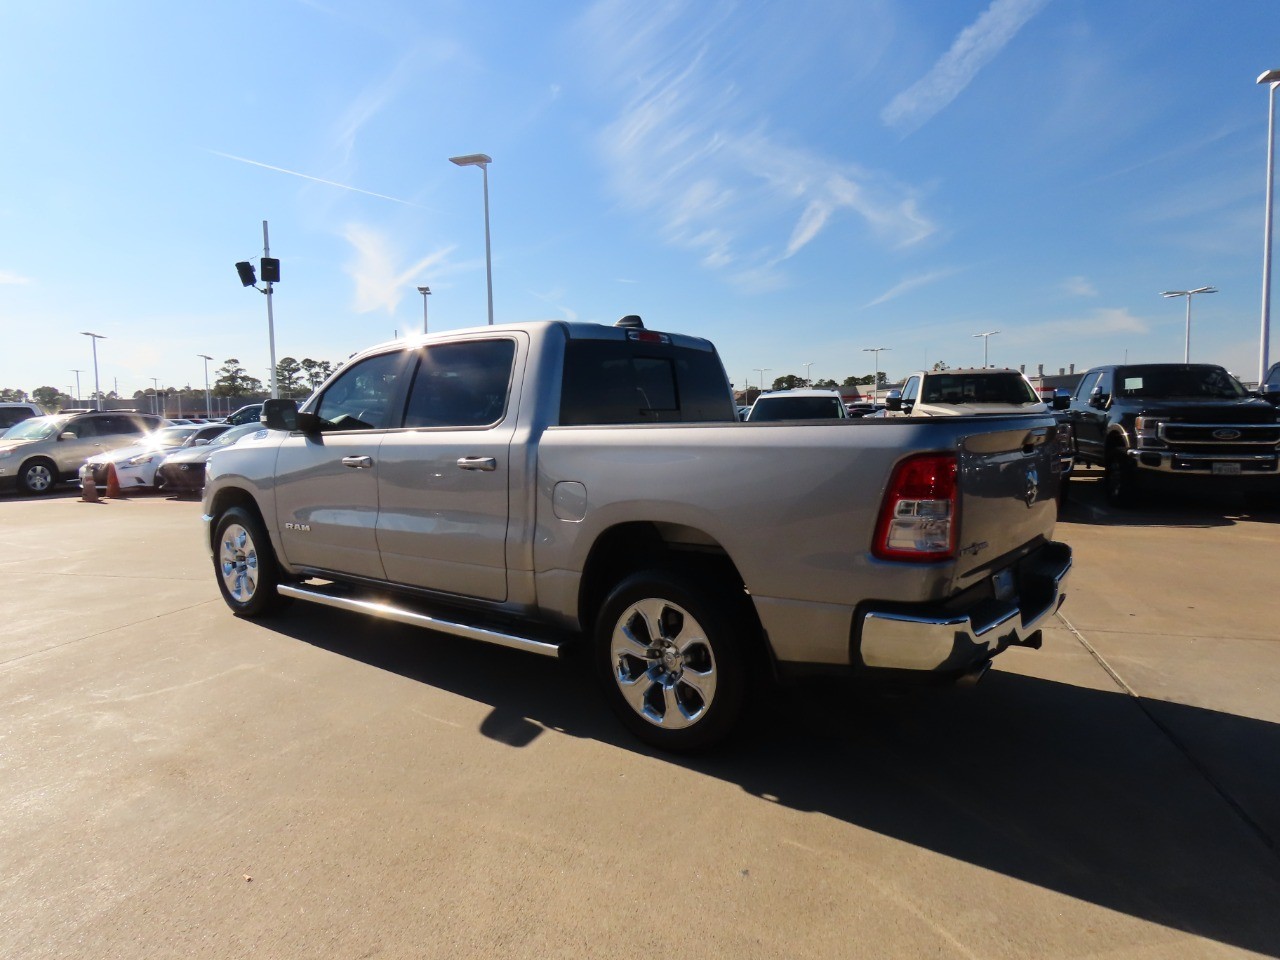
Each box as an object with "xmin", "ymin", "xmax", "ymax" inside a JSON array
[{"xmin": 559, "ymin": 339, "xmax": 737, "ymax": 426}]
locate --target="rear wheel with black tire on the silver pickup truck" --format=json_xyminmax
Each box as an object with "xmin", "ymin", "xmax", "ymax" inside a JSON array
[{"xmin": 594, "ymin": 570, "xmax": 751, "ymax": 751}]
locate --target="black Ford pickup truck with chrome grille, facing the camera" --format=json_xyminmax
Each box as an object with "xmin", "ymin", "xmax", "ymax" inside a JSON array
[{"xmin": 1068, "ymin": 364, "xmax": 1280, "ymax": 506}]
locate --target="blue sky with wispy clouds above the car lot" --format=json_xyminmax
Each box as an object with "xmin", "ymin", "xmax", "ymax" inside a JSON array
[{"xmin": 0, "ymin": 0, "xmax": 1280, "ymax": 396}]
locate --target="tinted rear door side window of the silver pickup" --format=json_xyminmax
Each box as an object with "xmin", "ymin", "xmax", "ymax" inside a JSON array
[{"xmin": 404, "ymin": 339, "xmax": 516, "ymax": 426}]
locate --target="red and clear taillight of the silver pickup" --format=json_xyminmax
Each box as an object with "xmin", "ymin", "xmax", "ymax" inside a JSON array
[{"xmin": 872, "ymin": 453, "xmax": 956, "ymax": 562}]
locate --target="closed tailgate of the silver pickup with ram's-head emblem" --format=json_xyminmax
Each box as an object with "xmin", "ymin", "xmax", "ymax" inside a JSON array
[{"xmin": 956, "ymin": 417, "xmax": 1059, "ymax": 584}]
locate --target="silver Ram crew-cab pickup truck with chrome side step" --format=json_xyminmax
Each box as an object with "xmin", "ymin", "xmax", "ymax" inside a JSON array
[{"xmin": 204, "ymin": 317, "xmax": 1071, "ymax": 750}]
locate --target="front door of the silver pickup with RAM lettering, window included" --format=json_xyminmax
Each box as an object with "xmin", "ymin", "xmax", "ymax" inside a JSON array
[{"xmin": 275, "ymin": 351, "xmax": 410, "ymax": 580}]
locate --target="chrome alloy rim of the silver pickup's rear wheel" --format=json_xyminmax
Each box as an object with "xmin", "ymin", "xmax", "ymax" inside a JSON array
[{"xmin": 609, "ymin": 598, "xmax": 716, "ymax": 730}]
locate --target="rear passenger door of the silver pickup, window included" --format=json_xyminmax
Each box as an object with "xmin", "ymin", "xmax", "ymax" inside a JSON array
[{"xmin": 378, "ymin": 335, "xmax": 522, "ymax": 602}]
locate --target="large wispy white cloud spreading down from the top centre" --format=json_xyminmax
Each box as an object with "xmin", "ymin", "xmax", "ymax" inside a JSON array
[{"xmin": 580, "ymin": 0, "xmax": 936, "ymax": 288}]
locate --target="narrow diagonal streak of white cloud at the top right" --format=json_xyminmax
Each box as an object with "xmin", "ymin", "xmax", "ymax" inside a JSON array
[{"xmin": 881, "ymin": 0, "xmax": 1048, "ymax": 133}]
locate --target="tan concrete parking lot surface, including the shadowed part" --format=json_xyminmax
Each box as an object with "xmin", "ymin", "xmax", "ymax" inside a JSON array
[{"xmin": 0, "ymin": 481, "xmax": 1280, "ymax": 960}]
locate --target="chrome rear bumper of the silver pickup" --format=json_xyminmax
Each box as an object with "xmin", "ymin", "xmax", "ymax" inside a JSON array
[{"xmin": 852, "ymin": 541, "xmax": 1071, "ymax": 675}]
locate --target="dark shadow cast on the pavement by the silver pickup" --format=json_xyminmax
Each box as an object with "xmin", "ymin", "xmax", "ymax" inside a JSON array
[{"xmin": 273, "ymin": 608, "xmax": 1280, "ymax": 956}]
